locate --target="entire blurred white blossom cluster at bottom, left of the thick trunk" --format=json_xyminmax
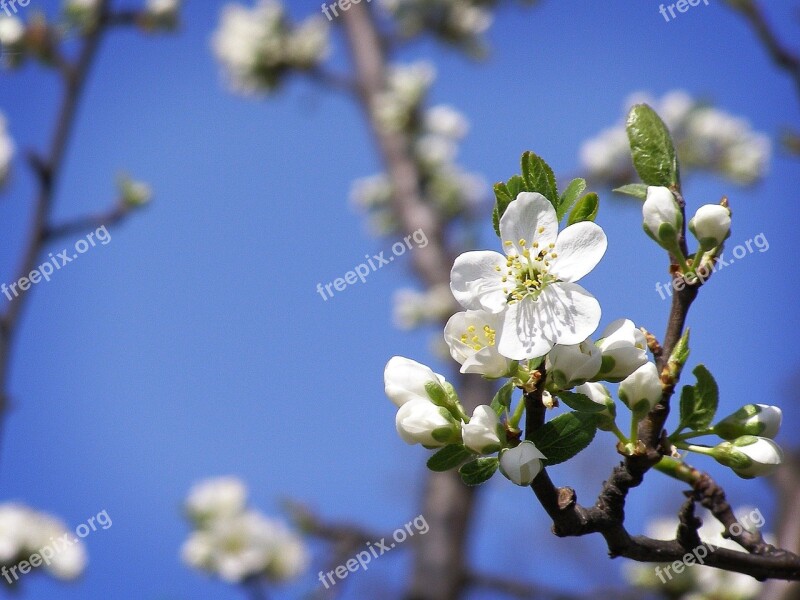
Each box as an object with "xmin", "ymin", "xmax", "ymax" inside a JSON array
[{"xmin": 182, "ymin": 477, "xmax": 309, "ymax": 584}]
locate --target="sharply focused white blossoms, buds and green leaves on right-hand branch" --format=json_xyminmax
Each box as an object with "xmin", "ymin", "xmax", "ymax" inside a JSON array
[{"xmin": 384, "ymin": 139, "xmax": 783, "ymax": 485}]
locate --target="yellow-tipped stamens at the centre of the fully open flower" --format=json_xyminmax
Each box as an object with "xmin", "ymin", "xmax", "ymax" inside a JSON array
[{"xmin": 495, "ymin": 239, "xmax": 558, "ymax": 304}]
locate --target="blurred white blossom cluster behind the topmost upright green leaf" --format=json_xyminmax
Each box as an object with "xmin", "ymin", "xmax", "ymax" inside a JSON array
[{"xmin": 580, "ymin": 90, "xmax": 771, "ymax": 187}]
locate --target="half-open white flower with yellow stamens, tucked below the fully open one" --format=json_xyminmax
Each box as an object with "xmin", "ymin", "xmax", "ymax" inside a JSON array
[{"xmin": 444, "ymin": 310, "xmax": 514, "ymax": 377}]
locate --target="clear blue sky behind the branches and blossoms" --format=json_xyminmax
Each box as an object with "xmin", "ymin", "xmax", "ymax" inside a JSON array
[{"xmin": 0, "ymin": 0, "xmax": 800, "ymax": 600}]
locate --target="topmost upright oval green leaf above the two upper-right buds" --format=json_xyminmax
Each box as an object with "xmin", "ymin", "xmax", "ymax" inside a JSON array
[{"xmin": 626, "ymin": 104, "xmax": 680, "ymax": 187}]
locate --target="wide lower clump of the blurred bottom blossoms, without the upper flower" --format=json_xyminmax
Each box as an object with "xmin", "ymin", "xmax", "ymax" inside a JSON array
[{"xmin": 181, "ymin": 510, "xmax": 309, "ymax": 583}]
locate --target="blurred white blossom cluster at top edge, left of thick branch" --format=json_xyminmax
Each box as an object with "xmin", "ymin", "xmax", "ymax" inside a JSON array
[{"xmin": 212, "ymin": 0, "xmax": 328, "ymax": 94}]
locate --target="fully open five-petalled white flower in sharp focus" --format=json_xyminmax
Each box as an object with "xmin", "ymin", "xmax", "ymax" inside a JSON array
[{"xmin": 450, "ymin": 192, "xmax": 607, "ymax": 360}]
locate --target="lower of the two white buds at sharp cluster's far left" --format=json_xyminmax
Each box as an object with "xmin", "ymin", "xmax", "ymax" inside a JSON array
[{"xmin": 395, "ymin": 398, "xmax": 461, "ymax": 448}]
